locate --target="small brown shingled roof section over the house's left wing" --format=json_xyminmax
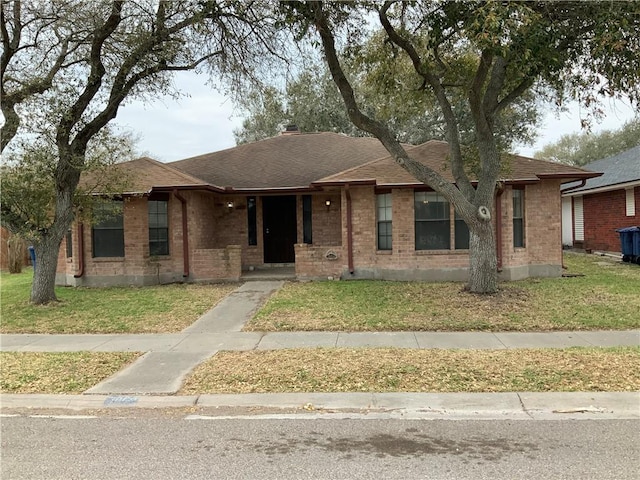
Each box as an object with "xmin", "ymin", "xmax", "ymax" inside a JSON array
[{"xmin": 110, "ymin": 157, "xmax": 210, "ymax": 194}]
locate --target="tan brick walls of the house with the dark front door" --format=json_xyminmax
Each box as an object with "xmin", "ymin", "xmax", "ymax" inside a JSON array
[{"xmin": 58, "ymin": 180, "xmax": 562, "ymax": 285}]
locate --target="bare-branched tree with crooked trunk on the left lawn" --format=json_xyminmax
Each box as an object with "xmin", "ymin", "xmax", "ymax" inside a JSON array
[{"xmin": 0, "ymin": 0, "xmax": 282, "ymax": 303}]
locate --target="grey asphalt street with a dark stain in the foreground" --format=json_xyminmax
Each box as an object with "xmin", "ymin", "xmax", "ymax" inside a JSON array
[{"xmin": 1, "ymin": 410, "xmax": 640, "ymax": 480}]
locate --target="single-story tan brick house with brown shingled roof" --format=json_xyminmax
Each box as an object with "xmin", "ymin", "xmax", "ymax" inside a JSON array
[{"xmin": 57, "ymin": 133, "xmax": 596, "ymax": 285}]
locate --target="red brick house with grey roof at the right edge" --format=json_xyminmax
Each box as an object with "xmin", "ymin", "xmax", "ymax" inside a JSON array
[{"xmin": 562, "ymin": 145, "xmax": 640, "ymax": 253}]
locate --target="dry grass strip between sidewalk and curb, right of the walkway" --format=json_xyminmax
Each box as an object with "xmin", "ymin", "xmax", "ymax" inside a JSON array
[{"xmin": 180, "ymin": 347, "xmax": 640, "ymax": 394}]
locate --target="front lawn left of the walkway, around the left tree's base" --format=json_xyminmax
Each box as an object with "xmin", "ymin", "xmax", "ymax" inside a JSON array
[{"xmin": 0, "ymin": 269, "xmax": 236, "ymax": 333}]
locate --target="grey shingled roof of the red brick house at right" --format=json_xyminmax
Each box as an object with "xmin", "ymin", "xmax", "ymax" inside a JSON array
[{"xmin": 571, "ymin": 145, "xmax": 640, "ymax": 195}]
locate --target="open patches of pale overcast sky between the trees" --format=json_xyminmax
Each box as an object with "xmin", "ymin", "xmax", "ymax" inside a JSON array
[{"xmin": 115, "ymin": 73, "xmax": 634, "ymax": 162}]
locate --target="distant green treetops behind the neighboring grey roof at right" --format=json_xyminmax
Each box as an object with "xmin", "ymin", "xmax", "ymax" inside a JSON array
[{"xmin": 534, "ymin": 117, "xmax": 640, "ymax": 166}]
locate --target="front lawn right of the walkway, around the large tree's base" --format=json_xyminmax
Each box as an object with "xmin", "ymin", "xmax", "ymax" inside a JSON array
[{"xmin": 245, "ymin": 253, "xmax": 640, "ymax": 331}]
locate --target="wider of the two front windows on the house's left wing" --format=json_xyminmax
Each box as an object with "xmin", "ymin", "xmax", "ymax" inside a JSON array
[{"xmin": 91, "ymin": 200, "xmax": 124, "ymax": 257}]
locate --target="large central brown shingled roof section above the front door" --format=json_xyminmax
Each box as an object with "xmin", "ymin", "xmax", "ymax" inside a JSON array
[{"xmin": 168, "ymin": 132, "xmax": 387, "ymax": 191}]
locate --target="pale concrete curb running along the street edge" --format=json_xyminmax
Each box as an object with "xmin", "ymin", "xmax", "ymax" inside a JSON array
[{"xmin": 0, "ymin": 392, "xmax": 640, "ymax": 420}]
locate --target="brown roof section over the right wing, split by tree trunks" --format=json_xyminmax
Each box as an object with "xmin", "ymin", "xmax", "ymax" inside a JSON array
[{"xmin": 313, "ymin": 140, "xmax": 598, "ymax": 186}]
